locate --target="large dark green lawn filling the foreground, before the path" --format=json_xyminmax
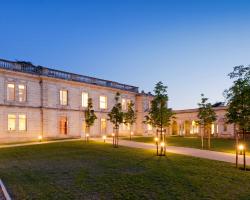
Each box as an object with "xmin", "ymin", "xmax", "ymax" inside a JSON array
[{"xmin": 0, "ymin": 141, "xmax": 250, "ymax": 200}]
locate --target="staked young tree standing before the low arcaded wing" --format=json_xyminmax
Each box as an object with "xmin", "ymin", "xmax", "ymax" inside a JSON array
[{"xmin": 197, "ymin": 94, "xmax": 217, "ymax": 149}]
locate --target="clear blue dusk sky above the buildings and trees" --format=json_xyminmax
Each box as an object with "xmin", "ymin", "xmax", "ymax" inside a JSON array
[{"xmin": 0, "ymin": 0, "xmax": 250, "ymax": 109}]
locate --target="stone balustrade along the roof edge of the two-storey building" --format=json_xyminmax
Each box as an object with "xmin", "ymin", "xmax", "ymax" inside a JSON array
[{"xmin": 0, "ymin": 59, "xmax": 138, "ymax": 93}]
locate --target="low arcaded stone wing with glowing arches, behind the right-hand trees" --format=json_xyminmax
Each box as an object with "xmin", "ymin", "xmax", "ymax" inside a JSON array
[{"xmin": 170, "ymin": 106, "xmax": 234, "ymax": 138}]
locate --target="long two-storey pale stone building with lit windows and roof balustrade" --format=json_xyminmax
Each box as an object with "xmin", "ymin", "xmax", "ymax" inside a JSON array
[{"xmin": 0, "ymin": 59, "xmax": 152, "ymax": 142}]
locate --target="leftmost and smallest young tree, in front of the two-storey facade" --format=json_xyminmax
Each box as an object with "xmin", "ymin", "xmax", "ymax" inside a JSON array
[{"xmin": 84, "ymin": 98, "xmax": 97, "ymax": 140}]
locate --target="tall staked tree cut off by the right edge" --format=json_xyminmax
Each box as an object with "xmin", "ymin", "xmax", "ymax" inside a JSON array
[{"xmin": 224, "ymin": 65, "xmax": 250, "ymax": 169}]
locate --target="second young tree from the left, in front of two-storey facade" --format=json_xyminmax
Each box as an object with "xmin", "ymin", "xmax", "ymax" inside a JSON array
[{"xmin": 108, "ymin": 92, "xmax": 124, "ymax": 148}]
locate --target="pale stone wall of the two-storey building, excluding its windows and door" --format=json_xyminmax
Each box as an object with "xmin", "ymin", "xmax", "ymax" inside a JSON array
[{"xmin": 0, "ymin": 69, "xmax": 152, "ymax": 142}]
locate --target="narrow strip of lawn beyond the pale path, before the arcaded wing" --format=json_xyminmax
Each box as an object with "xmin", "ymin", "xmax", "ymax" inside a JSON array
[{"xmin": 123, "ymin": 136, "xmax": 250, "ymax": 154}]
